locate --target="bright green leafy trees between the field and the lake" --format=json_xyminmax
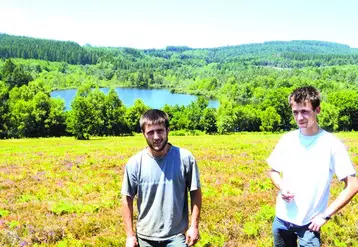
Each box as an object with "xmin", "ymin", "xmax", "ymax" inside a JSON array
[{"xmin": 0, "ymin": 60, "xmax": 358, "ymax": 139}]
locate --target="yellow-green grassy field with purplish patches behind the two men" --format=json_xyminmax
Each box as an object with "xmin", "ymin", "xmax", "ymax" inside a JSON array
[{"xmin": 0, "ymin": 132, "xmax": 358, "ymax": 247}]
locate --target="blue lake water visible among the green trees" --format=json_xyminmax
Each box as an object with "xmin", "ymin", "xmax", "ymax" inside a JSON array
[{"xmin": 51, "ymin": 88, "xmax": 219, "ymax": 110}]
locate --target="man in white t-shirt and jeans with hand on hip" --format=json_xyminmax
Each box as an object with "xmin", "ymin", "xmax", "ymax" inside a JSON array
[{"xmin": 267, "ymin": 87, "xmax": 358, "ymax": 247}]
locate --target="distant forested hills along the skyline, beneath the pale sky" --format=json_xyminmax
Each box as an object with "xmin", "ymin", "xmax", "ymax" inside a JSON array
[{"xmin": 0, "ymin": 34, "xmax": 358, "ymax": 68}]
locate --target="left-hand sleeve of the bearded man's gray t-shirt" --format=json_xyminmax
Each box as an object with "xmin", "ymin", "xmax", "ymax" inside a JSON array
[{"xmin": 121, "ymin": 157, "xmax": 138, "ymax": 198}]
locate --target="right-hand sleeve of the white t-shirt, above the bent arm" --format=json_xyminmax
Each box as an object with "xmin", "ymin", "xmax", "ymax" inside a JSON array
[{"xmin": 332, "ymin": 140, "xmax": 356, "ymax": 180}]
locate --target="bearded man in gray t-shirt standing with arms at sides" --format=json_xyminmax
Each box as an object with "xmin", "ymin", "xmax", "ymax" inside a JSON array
[{"xmin": 122, "ymin": 110, "xmax": 201, "ymax": 247}]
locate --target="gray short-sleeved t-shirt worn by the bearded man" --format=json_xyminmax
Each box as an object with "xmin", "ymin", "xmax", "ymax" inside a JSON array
[{"xmin": 122, "ymin": 146, "xmax": 200, "ymax": 241}]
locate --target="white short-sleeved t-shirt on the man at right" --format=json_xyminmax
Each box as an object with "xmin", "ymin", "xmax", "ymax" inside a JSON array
[{"xmin": 267, "ymin": 130, "xmax": 355, "ymax": 226}]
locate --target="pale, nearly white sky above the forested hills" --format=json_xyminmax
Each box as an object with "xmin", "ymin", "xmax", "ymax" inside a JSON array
[{"xmin": 0, "ymin": 0, "xmax": 358, "ymax": 49}]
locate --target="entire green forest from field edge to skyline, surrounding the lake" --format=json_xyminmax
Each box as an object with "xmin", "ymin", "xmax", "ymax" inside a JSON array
[{"xmin": 0, "ymin": 34, "xmax": 358, "ymax": 139}]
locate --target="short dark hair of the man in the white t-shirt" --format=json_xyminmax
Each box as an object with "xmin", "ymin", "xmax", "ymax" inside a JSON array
[{"xmin": 288, "ymin": 86, "xmax": 321, "ymax": 110}]
